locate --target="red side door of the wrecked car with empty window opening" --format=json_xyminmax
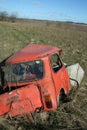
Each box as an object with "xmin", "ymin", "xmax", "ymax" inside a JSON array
[{"xmin": 50, "ymin": 53, "xmax": 67, "ymax": 95}]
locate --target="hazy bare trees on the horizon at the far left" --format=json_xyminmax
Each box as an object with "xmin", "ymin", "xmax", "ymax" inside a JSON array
[{"xmin": 0, "ymin": 11, "xmax": 17, "ymax": 22}]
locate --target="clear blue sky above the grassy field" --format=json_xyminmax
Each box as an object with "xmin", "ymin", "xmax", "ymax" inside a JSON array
[{"xmin": 0, "ymin": 0, "xmax": 87, "ymax": 24}]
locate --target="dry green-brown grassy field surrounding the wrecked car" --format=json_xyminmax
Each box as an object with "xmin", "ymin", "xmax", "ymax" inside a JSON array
[{"xmin": 0, "ymin": 20, "xmax": 87, "ymax": 130}]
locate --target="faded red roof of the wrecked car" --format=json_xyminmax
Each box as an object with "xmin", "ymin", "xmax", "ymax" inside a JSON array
[{"xmin": 6, "ymin": 44, "xmax": 61, "ymax": 63}]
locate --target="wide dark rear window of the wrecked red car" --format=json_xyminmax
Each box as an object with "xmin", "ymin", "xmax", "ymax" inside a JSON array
[{"xmin": 5, "ymin": 60, "xmax": 43, "ymax": 82}]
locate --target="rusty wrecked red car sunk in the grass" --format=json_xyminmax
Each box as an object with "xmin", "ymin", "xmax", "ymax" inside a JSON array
[{"xmin": 0, "ymin": 44, "xmax": 71, "ymax": 117}]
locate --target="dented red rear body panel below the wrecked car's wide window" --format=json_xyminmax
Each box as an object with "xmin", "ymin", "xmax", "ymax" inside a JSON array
[{"xmin": 0, "ymin": 85, "xmax": 42, "ymax": 117}]
